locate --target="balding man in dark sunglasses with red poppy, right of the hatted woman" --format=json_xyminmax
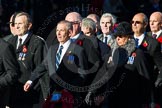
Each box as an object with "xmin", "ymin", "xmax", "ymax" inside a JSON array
[{"xmin": 131, "ymin": 13, "xmax": 162, "ymax": 105}]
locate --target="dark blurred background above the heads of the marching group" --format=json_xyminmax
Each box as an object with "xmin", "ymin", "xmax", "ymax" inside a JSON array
[{"xmin": 0, "ymin": 0, "xmax": 162, "ymax": 39}]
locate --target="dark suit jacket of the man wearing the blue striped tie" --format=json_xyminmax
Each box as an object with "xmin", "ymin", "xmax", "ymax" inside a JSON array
[{"xmin": 30, "ymin": 43, "xmax": 88, "ymax": 98}]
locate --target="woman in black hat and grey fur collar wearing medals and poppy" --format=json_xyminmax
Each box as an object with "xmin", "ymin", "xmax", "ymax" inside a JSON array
[{"xmin": 87, "ymin": 22, "xmax": 149, "ymax": 108}]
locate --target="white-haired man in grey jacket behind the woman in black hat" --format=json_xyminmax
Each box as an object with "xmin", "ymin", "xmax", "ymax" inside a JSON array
[{"xmin": 98, "ymin": 13, "xmax": 116, "ymax": 47}]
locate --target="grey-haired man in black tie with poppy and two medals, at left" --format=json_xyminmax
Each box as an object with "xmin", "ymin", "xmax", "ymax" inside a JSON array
[{"xmin": 8, "ymin": 12, "xmax": 45, "ymax": 108}]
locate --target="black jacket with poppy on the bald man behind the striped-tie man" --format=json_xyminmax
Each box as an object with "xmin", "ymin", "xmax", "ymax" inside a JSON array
[{"xmin": 75, "ymin": 33, "xmax": 102, "ymax": 86}]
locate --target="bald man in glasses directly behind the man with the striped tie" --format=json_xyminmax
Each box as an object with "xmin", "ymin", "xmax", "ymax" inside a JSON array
[{"xmin": 65, "ymin": 12, "xmax": 101, "ymax": 106}]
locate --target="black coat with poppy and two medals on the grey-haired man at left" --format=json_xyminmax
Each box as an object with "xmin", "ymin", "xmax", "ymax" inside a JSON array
[{"xmin": 8, "ymin": 33, "xmax": 45, "ymax": 108}]
